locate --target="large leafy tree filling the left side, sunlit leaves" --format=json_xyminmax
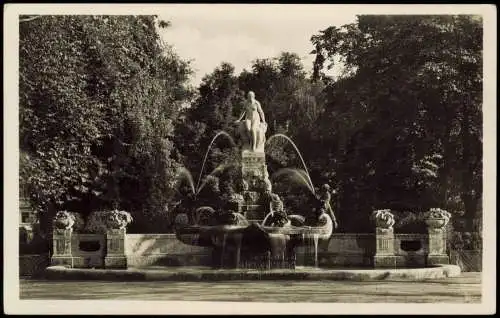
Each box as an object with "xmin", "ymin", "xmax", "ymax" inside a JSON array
[{"xmin": 19, "ymin": 16, "xmax": 191, "ymax": 232}]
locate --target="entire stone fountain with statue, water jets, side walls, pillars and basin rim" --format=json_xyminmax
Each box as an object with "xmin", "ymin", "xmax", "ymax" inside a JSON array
[{"xmin": 44, "ymin": 90, "xmax": 460, "ymax": 281}]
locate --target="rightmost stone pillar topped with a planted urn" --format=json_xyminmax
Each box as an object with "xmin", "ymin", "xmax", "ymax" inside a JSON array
[{"xmin": 425, "ymin": 209, "xmax": 451, "ymax": 265}]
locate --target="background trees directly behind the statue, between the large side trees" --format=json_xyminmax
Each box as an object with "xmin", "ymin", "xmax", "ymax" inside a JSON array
[{"xmin": 175, "ymin": 52, "xmax": 323, "ymax": 216}]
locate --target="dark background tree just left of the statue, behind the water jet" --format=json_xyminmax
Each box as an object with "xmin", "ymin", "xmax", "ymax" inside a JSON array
[{"xmin": 175, "ymin": 63, "xmax": 244, "ymax": 193}]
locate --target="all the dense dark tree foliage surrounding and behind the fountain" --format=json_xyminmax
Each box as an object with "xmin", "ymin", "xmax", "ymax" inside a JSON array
[{"xmin": 20, "ymin": 16, "xmax": 482, "ymax": 232}]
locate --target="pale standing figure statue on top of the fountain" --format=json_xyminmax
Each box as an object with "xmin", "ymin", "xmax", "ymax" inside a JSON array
[{"xmin": 236, "ymin": 91, "xmax": 267, "ymax": 152}]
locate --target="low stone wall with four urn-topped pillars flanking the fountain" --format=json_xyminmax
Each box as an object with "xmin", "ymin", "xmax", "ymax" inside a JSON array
[{"xmin": 47, "ymin": 209, "xmax": 450, "ymax": 268}]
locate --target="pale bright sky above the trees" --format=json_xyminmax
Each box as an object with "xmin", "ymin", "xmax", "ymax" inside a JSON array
[{"xmin": 158, "ymin": 4, "xmax": 356, "ymax": 85}]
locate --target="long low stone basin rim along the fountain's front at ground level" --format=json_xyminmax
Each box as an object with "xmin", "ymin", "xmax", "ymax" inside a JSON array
[{"xmin": 43, "ymin": 264, "xmax": 461, "ymax": 282}]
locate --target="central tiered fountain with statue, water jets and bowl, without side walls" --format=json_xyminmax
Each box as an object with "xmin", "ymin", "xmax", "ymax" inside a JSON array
[{"xmin": 176, "ymin": 93, "xmax": 336, "ymax": 269}]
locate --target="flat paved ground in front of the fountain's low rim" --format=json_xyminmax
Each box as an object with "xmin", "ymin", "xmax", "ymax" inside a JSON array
[{"xmin": 20, "ymin": 273, "xmax": 481, "ymax": 303}]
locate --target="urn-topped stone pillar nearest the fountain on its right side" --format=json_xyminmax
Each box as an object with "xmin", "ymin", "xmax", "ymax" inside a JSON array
[{"xmin": 372, "ymin": 210, "xmax": 396, "ymax": 268}]
